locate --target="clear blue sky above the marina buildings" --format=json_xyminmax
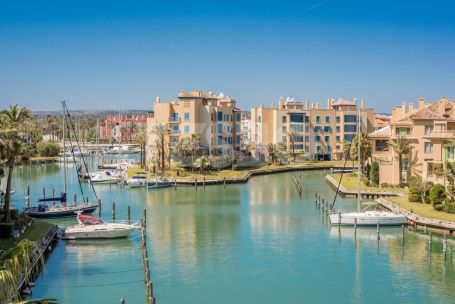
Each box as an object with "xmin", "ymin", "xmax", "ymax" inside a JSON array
[{"xmin": 0, "ymin": 0, "xmax": 455, "ymax": 113}]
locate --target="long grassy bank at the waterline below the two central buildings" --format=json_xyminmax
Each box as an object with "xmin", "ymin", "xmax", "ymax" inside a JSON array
[{"xmin": 127, "ymin": 161, "xmax": 350, "ymax": 180}]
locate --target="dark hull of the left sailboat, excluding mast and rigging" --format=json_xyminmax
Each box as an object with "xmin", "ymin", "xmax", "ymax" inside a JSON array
[{"xmin": 25, "ymin": 204, "xmax": 98, "ymax": 218}]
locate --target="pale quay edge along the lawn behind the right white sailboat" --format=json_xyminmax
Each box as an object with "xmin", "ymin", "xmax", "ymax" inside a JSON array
[{"xmin": 376, "ymin": 197, "xmax": 455, "ymax": 235}]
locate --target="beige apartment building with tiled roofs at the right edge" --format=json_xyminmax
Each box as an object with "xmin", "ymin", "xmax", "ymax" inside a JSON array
[{"xmin": 368, "ymin": 97, "xmax": 455, "ymax": 184}]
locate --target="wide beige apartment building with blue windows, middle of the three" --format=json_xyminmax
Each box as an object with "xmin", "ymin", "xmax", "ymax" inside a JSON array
[{"xmin": 251, "ymin": 98, "xmax": 374, "ymax": 160}]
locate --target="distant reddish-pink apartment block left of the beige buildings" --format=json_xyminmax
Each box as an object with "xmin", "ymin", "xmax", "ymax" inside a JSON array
[{"xmin": 100, "ymin": 115, "xmax": 147, "ymax": 143}]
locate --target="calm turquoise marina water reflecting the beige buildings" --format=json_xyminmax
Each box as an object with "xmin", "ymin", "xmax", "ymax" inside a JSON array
[{"xmin": 9, "ymin": 165, "xmax": 455, "ymax": 304}]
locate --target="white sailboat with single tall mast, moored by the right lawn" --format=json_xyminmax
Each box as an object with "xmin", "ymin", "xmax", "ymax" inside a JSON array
[{"xmin": 329, "ymin": 110, "xmax": 407, "ymax": 226}]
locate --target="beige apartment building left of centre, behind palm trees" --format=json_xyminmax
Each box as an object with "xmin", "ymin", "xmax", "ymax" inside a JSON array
[{"xmin": 147, "ymin": 90, "xmax": 241, "ymax": 165}]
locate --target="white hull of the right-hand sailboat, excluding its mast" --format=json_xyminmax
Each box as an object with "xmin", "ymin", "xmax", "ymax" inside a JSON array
[{"xmin": 330, "ymin": 210, "xmax": 407, "ymax": 226}]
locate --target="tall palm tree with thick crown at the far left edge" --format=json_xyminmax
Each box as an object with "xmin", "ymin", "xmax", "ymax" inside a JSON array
[{"xmin": 0, "ymin": 105, "xmax": 32, "ymax": 222}]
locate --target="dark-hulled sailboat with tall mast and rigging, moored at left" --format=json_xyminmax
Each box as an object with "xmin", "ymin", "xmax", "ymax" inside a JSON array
[{"xmin": 24, "ymin": 101, "xmax": 98, "ymax": 218}]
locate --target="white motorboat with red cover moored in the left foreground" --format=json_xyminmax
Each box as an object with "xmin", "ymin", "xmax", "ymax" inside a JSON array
[{"xmin": 62, "ymin": 213, "xmax": 141, "ymax": 240}]
